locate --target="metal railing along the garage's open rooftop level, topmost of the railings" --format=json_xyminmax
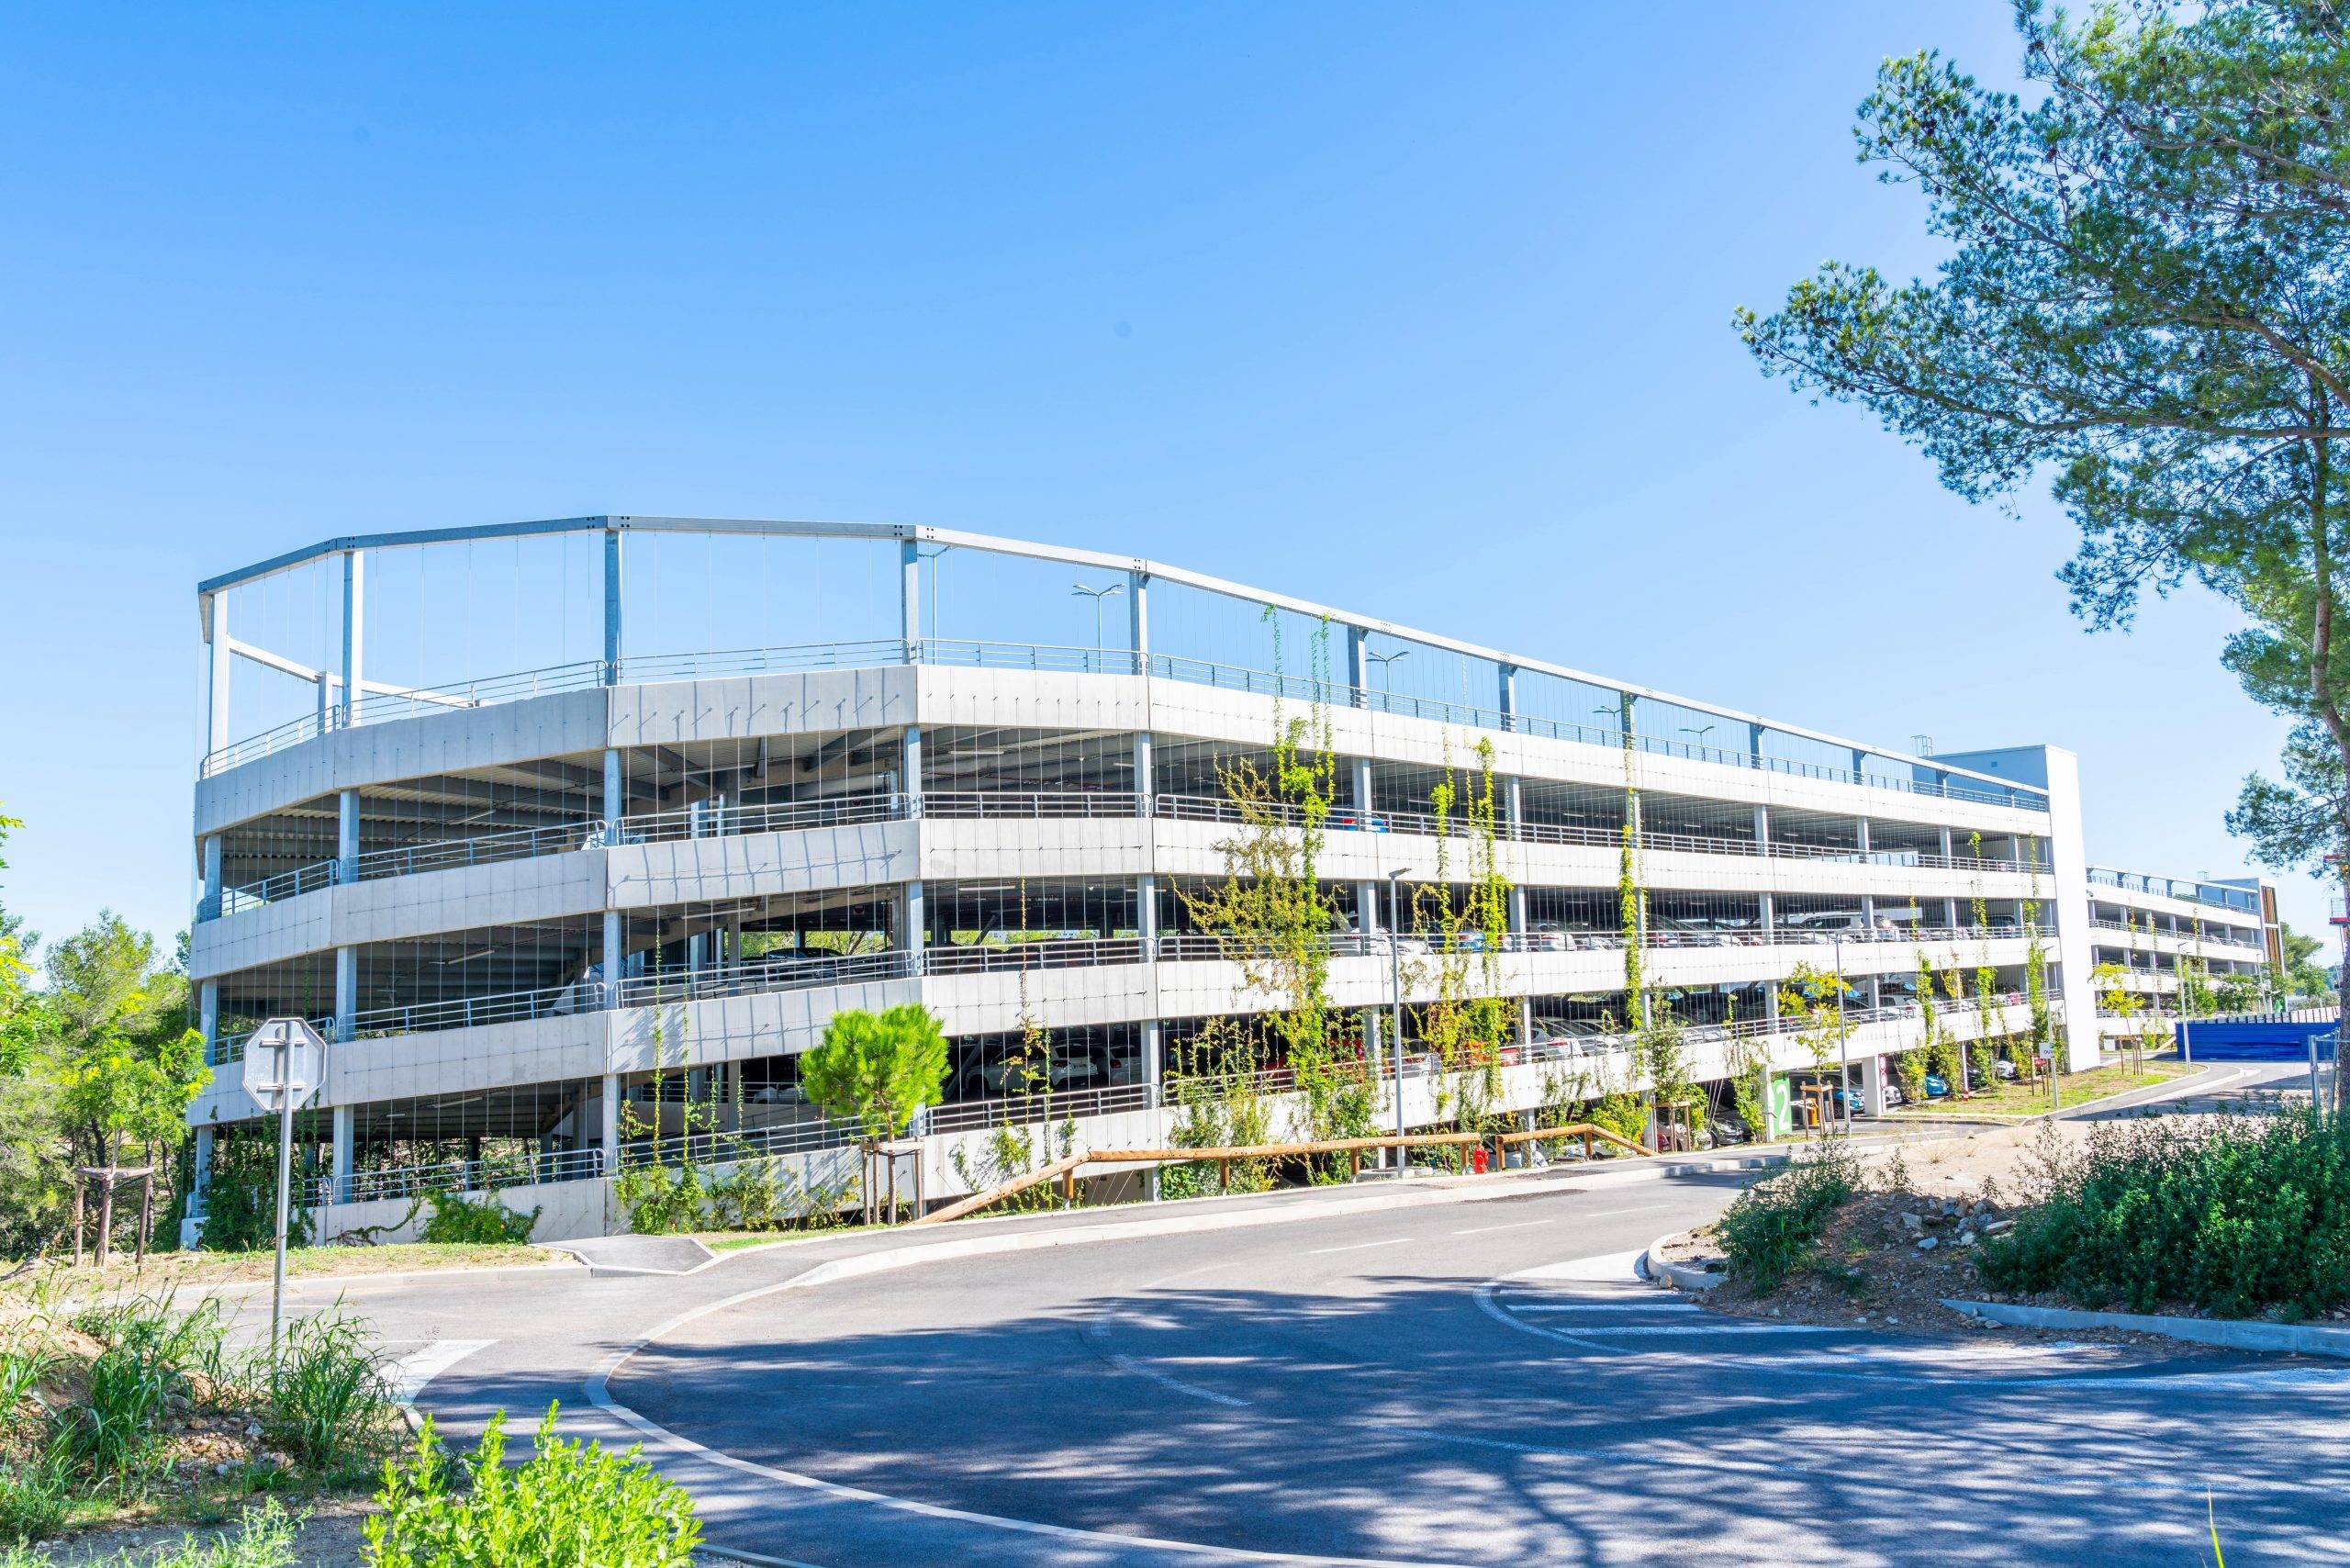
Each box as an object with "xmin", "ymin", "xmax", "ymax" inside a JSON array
[{"xmin": 197, "ymin": 637, "xmax": 2047, "ymax": 811}]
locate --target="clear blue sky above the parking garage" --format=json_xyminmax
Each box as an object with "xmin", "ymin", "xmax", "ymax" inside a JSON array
[{"xmin": 0, "ymin": 0, "xmax": 2322, "ymax": 935}]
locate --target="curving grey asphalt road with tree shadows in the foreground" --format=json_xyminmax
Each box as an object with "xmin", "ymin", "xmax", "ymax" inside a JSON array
[{"xmin": 233, "ymin": 1067, "xmax": 2350, "ymax": 1568}]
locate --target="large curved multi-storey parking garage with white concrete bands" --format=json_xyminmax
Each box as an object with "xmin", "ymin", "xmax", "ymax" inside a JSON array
[{"xmin": 190, "ymin": 517, "xmax": 2098, "ymax": 1234}]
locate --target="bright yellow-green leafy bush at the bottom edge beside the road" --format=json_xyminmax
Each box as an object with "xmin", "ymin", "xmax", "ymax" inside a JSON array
[{"xmin": 366, "ymin": 1406, "xmax": 700, "ymax": 1568}]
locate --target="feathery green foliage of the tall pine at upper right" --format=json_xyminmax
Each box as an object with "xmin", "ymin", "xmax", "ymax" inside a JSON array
[{"xmin": 1737, "ymin": 0, "xmax": 2350, "ymax": 1100}]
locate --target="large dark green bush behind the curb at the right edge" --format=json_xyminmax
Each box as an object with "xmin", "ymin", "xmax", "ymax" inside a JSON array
[{"xmin": 1976, "ymin": 1112, "xmax": 2350, "ymax": 1316}]
